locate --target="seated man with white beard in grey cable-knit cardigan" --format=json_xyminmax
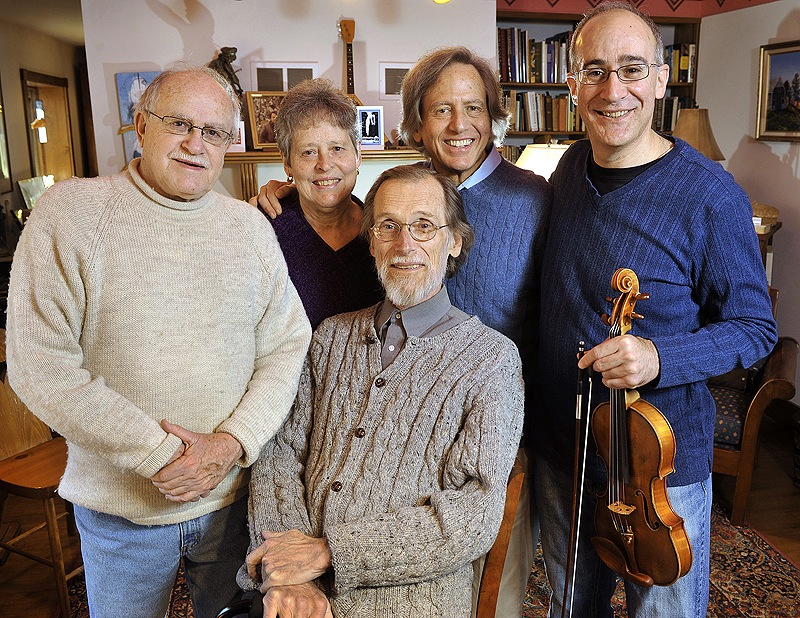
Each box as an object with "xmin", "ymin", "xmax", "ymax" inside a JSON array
[{"xmin": 239, "ymin": 166, "xmax": 523, "ymax": 618}]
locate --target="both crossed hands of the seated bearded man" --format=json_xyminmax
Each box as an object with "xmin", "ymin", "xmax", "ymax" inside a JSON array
[{"xmin": 246, "ymin": 530, "xmax": 333, "ymax": 618}]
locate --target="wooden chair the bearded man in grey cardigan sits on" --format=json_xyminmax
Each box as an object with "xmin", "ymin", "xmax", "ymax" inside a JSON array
[{"xmin": 217, "ymin": 459, "xmax": 525, "ymax": 618}]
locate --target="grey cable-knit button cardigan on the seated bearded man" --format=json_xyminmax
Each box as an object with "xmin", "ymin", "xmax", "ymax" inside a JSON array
[{"xmin": 239, "ymin": 307, "xmax": 523, "ymax": 618}]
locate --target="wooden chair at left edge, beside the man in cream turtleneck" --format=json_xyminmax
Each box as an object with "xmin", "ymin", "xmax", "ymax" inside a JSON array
[{"xmin": 0, "ymin": 331, "xmax": 83, "ymax": 617}]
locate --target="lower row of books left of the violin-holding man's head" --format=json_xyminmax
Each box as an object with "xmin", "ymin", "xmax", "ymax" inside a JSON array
[{"xmin": 503, "ymin": 89, "xmax": 584, "ymax": 132}]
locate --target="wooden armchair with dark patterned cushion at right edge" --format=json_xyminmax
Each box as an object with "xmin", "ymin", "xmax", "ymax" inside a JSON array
[{"xmin": 709, "ymin": 337, "xmax": 798, "ymax": 526}]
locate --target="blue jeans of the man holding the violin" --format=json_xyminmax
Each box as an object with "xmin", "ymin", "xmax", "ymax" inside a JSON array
[{"xmin": 534, "ymin": 457, "xmax": 711, "ymax": 618}]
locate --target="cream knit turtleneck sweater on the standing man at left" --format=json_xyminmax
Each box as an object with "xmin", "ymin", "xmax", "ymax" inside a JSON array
[{"xmin": 7, "ymin": 160, "xmax": 310, "ymax": 524}]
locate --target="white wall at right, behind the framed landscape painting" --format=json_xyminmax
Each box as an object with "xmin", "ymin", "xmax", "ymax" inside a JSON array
[{"xmin": 697, "ymin": 0, "xmax": 800, "ymax": 400}]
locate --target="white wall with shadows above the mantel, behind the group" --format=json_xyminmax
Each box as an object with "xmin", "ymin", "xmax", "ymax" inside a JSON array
[{"xmin": 81, "ymin": 0, "xmax": 497, "ymax": 175}]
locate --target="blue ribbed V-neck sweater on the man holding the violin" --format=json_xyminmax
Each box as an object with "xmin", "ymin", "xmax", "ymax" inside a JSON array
[{"xmin": 534, "ymin": 139, "xmax": 777, "ymax": 485}]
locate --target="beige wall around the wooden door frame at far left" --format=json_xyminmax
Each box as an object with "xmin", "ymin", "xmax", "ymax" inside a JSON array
[{"xmin": 0, "ymin": 20, "xmax": 83, "ymax": 205}]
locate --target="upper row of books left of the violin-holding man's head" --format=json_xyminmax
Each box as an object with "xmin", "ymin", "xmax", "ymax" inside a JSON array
[{"xmin": 497, "ymin": 27, "xmax": 572, "ymax": 84}]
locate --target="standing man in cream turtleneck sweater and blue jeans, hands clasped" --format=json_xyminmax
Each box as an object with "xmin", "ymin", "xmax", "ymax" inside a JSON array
[{"xmin": 8, "ymin": 67, "xmax": 310, "ymax": 618}]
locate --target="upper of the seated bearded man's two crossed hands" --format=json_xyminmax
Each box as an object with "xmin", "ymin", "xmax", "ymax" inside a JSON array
[{"xmin": 247, "ymin": 529, "xmax": 332, "ymax": 592}]
